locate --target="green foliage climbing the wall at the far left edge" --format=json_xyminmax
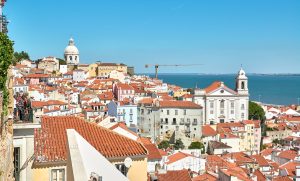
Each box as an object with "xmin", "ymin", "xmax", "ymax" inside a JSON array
[{"xmin": 0, "ymin": 33, "xmax": 14, "ymax": 115}]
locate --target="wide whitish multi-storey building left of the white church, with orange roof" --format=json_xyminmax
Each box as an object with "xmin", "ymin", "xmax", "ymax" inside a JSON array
[{"xmin": 138, "ymin": 100, "xmax": 203, "ymax": 146}]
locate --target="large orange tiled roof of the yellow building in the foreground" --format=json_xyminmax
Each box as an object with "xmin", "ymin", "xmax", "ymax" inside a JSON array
[{"xmin": 34, "ymin": 116, "xmax": 147, "ymax": 162}]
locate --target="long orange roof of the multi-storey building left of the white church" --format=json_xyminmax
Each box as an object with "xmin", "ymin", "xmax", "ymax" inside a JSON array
[{"xmin": 159, "ymin": 101, "xmax": 202, "ymax": 109}]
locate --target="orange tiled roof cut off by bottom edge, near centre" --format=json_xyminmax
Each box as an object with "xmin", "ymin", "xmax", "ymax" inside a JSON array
[{"xmin": 157, "ymin": 170, "xmax": 192, "ymax": 181}]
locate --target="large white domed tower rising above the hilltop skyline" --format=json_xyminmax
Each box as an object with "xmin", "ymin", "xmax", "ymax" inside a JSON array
[{"xmin": 64, "ymin": 38, "xmax": 79, "ymax": 67}]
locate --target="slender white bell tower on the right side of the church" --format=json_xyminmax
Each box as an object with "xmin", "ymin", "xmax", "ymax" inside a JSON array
[{"xmin": 235, "ymin": 67, "xmax": 249, "ymax": 95}]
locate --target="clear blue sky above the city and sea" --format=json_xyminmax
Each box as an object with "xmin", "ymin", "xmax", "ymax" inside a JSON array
[{"xmin": 4, "ymin": 0, "xmax": 300, "ymax": 73}]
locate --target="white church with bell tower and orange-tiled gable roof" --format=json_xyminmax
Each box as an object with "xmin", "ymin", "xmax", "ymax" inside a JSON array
[{"xmin": 194, "ymin": 69, "xmax": 249, "ymax": 124}]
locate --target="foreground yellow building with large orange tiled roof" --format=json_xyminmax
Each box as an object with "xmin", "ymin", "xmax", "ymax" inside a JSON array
[{"xmin": 32, "ymin": 116, "xmax": 147, "ymax": 181}]
